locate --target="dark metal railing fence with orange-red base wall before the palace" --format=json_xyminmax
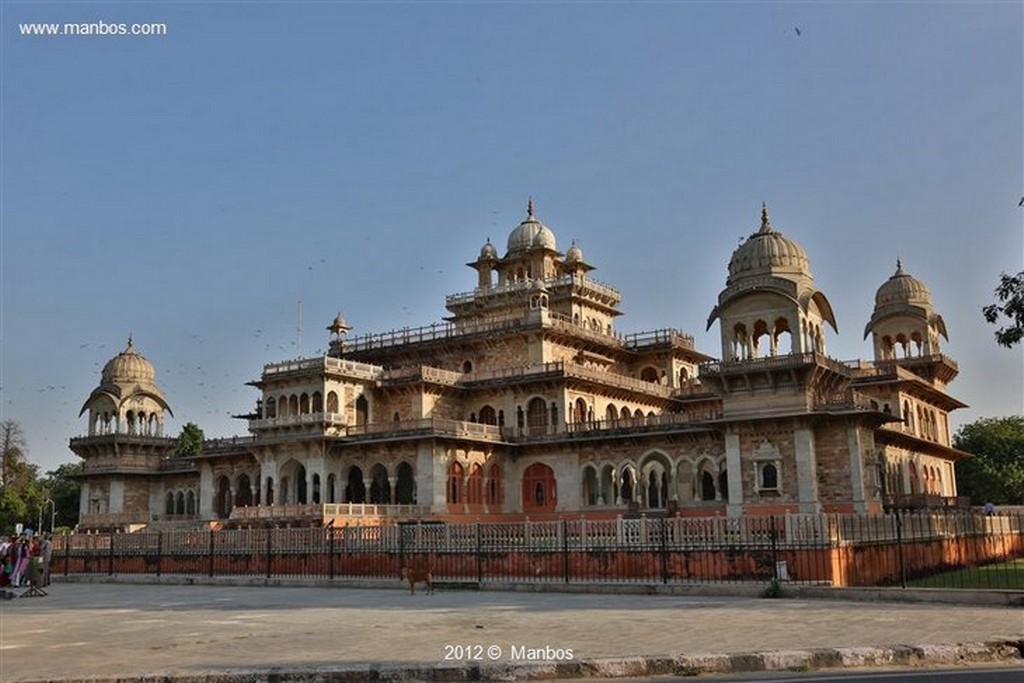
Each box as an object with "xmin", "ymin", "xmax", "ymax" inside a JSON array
[{"xmin": 52, "ymin": 514, "xmax": 1024, "ymax": 589}]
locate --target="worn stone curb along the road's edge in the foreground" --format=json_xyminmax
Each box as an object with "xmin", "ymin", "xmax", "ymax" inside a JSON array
[{"xmin": 22, "ymin": 639, "xmax": 1024, "ymax": 683}]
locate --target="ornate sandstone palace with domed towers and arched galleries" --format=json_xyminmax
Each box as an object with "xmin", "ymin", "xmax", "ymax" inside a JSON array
[{"xmin": 71, "ymin": 202, "xmax": 968, "ymax": 530}]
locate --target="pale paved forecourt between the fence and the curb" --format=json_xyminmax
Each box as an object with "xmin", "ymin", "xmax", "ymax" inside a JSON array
[{"xmin": 0, "ymin": 582, "xmax": 1024, "ymax": 681}]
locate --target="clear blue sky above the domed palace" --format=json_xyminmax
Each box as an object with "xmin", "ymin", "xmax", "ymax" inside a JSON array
[{"xmin": 0, "ymin": 1, "xmax": 1024, "ymax": 470}]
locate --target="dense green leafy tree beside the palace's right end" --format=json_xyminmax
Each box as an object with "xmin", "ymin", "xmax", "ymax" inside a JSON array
[{"xmin": 953, "ymin": 416, "xmax": 1024, "ymax": 505}]
